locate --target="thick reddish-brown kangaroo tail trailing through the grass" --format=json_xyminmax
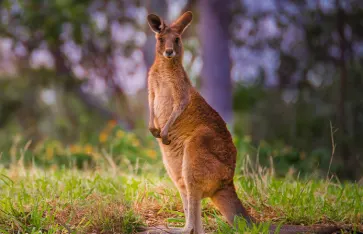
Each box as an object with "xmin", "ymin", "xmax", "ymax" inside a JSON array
[{"xmin": 211, "ymin": 183, "xmax": 346, "ymax": 234}]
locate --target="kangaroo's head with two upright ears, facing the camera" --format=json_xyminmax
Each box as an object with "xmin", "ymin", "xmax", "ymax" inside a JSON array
[{"xmin": 147, "ymin": 11, "xmax": 193, "ymax": 59}]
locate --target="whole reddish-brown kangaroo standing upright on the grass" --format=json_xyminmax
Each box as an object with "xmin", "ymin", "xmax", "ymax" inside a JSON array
[{"xmin": 147, "ymin": 12, "xmax": 342, "ymax": 234}]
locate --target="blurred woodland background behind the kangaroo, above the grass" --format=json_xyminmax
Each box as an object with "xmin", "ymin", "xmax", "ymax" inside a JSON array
[{"xmin": 0, "ymin": 0, "xmax": 363, "ymax": 180}]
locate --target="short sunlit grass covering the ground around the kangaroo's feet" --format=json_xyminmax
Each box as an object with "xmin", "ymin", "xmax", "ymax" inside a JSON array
[{"xmin": 0, "ymin": 167, "xmax": 363, "ymax": 233}]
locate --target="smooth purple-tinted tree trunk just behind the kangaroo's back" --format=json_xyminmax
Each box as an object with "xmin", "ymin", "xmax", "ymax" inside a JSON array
[{"xmin": 199, "ymin": 0, "xmax": 233, "ymax": 124}]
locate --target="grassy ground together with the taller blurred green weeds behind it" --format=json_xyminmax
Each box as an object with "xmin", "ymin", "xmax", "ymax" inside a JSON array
[{"xmin": 0, "ymin": 128, "xmax": 363, "ymax": 234}]
